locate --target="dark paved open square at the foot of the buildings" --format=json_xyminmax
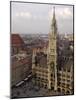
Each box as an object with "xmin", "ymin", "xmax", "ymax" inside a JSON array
[{"xmin": 11, "ymin": 81, "xmax": 61, "ymax": 98}]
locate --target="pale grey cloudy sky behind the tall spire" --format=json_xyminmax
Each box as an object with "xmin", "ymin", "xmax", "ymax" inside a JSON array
[{"xmin": 11, "ymin": 2, "xmax": 73, "ymax": 34}]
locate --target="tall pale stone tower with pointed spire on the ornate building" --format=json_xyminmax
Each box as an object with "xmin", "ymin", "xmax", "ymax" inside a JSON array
[{"xmin": 47, "ymin": 7, "xmax": 57, "ymax": 90}]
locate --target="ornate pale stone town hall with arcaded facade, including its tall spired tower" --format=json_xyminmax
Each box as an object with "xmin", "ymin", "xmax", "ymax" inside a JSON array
[{"xmin": 32, "ymin": 8, "xmax": 74, "ymax": 94}]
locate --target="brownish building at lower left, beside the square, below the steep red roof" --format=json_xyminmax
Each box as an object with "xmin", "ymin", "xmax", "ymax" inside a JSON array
[{"xmin": 11, "ymin": 56, "xmax": 32, "ymax": 86}]
